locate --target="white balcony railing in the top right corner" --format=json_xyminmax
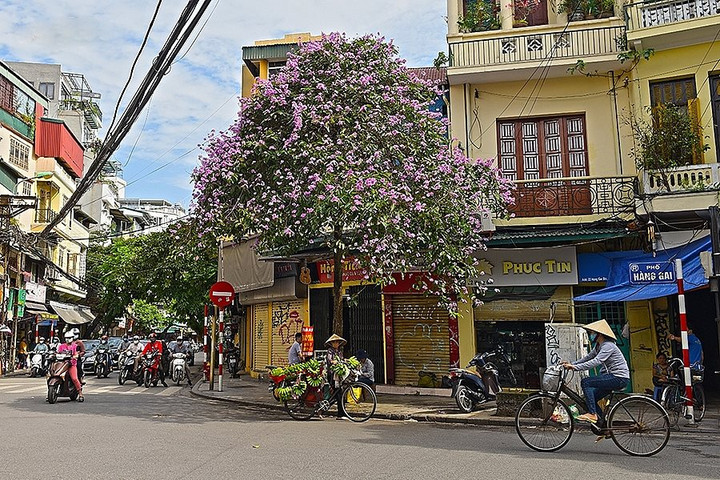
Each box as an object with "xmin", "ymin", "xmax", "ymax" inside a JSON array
[{"xmin": 625, "ymin": 0, "xmax": 720, "ymax": 30}]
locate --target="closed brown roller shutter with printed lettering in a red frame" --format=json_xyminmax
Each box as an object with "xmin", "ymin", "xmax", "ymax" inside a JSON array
[{"xmin": 392, "ymin": 295, "xmax": 450, "ymax": 386}]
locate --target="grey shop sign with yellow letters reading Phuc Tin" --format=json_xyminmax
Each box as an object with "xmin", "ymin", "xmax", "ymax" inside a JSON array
[{"xmin": 468, "ymin": 247, "xmax": 578, "ymax": 287}]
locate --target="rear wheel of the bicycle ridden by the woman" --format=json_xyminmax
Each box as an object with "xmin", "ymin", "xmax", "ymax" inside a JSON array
[{"xmin": 607, "ymin": 395, "xmax": 670, "ymax": 457}]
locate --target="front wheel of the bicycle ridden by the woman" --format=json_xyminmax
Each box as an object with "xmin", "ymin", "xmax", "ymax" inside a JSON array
[{"xmin": 515, "ymin": 394, "xmax": 575, "ymax": 452}]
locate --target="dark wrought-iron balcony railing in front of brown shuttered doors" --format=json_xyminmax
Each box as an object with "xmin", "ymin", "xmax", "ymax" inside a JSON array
[{"xmin": 511, "ymin": 177, "xmax": 636, "ymax": 217}]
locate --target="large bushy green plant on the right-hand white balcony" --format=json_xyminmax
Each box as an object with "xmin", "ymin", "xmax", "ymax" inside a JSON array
[{"xmin": 628, "ymin": 104, "xmax": 710, "ymax": 192}]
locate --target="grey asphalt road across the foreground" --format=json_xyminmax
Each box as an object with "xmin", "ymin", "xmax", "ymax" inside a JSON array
[{"xmin": 0, "ymin": 373, "xmax": 720, "ymax": 480}]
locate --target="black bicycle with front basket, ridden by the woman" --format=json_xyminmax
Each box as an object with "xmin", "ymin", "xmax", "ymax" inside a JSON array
[{"xmin": 515, "ymin": 366, "xmax": 670, "ymax": 457}]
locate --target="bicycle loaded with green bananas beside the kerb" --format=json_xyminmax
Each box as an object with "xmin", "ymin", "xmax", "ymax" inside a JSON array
[{"xmin": 271, "ymin": 368, "xmax": 377, "ymax": 422}]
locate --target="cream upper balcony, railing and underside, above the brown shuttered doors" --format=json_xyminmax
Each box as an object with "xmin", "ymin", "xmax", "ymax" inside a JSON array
[{"xmin": 448, "ymin": 22, "xmax": 625, "ymax": 81}]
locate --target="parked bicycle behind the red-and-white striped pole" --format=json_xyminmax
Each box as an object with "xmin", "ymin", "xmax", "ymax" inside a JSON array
[{"xmin": 660, "ymin": 358, "xmax": 705, "ymax": 427}]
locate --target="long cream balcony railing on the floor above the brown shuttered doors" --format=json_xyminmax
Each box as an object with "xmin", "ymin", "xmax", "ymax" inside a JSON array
[{"xmin": 450, "ymin": 26, "xmax": 625, "ymax": 67}]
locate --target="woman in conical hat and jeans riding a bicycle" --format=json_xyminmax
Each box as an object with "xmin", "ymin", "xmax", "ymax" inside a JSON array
[{"xmin": 563, "ymin": 320, "xmax": 630, "ymax": 423}]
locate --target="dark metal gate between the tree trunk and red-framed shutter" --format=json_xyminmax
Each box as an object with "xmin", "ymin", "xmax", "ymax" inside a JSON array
[{"xmin": 343, "ymin": 285, "xmax": 385, "ymax": 383}]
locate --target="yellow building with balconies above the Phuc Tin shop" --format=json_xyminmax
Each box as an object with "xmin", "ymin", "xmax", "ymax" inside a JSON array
[{"xmin": 447, "ymin": 0, "xmax": 720, "ymax": 391}]
